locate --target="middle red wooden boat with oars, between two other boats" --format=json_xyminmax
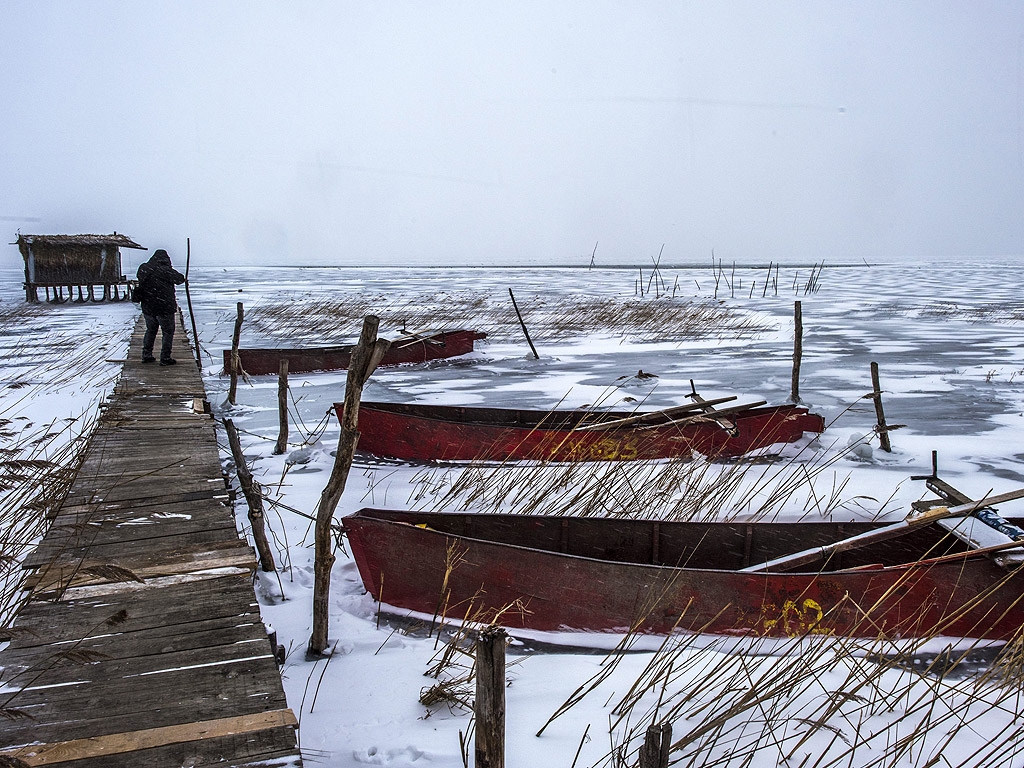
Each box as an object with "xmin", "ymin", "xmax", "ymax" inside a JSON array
[{"xmin": 335, "ymin": 397, "xmax": 824, "ymax": 462}]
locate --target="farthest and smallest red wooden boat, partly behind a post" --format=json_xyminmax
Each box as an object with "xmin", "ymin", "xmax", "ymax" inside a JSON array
[{"xmin": 224, "ymin": 329, "xmax": 487, "ymax": 376}]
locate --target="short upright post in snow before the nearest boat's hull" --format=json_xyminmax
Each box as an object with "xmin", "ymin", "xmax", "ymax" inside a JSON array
[{"xmin": 473, "ymin": 627, "xmax": 506, "ymax": 768}]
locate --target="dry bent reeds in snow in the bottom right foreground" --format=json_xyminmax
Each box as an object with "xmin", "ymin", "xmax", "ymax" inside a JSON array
[{"xmin": 539, "ymin": 585, "xmax": 1024, "ymax": 768}]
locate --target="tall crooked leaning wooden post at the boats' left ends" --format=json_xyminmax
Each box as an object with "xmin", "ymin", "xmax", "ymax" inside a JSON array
[{"xmin": 306, "ymin": 314, "xmax": 391, "ymax": 658}]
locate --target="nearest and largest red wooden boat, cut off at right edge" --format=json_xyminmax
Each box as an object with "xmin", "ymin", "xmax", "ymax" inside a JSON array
[{"xmin": 343, "ymin": 509, "xmax": 1024, "ymax": 639}]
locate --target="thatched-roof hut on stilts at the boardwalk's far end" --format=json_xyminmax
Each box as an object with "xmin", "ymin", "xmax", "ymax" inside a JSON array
[{"xmin": 16, "ymin": 232, "xmax": 146, "ymax": 301}]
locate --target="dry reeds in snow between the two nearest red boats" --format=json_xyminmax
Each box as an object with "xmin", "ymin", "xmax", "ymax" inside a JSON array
[{"xmin": 408, "ymin": 430, "xmax": 866, "ymax": 520}]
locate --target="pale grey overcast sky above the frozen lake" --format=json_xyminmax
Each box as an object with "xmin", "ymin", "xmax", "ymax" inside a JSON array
[{"xmin": 0, "ymin": 0, "xmax": 1024, "ymax": 266}]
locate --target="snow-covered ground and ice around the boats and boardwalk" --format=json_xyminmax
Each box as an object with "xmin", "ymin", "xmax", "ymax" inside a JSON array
[{"xmin": 0, "ymin": 262, "xmax": 1024, "ymax": 768}]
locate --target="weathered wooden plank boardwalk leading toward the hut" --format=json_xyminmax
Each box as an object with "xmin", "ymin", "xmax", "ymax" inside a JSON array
[{"xmin": 0, "ymin": 318, "xmax": 301, "ymax": 768}]
